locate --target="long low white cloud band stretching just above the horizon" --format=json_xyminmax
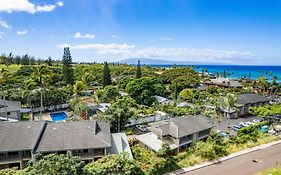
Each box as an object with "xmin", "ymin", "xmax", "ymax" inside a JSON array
[{"xmin": 57, "ymin": 43, "xmax": 255, "ymax": 62}]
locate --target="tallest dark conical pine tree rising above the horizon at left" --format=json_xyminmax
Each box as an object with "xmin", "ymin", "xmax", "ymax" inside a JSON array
[{"xmin": 62, "ymin": 47, "xmax": 74, "ymax": 85}]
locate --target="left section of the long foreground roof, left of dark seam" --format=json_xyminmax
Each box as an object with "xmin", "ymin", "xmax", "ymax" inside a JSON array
[{"xmin": 0, "ymin": 121, "xmax": 45, "ymax": 152}]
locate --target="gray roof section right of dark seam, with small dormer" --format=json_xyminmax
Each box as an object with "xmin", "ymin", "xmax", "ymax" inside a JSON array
[{"xmin": 36, "ymin": 121, "xmax": 111, "ymax": 152}]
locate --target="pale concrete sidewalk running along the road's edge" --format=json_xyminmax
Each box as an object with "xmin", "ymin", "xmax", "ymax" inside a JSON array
[{"xmin": 165, "ymin": 140, "xmax": 281, "ymax": 175}]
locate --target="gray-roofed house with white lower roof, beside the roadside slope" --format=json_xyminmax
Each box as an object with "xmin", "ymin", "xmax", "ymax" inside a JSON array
[{"xmin": 136, "ymin": 115, "xmax": 214, "ymax": 153}]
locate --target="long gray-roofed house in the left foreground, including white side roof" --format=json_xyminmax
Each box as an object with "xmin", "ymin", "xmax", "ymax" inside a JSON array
[{"xmin": 0, "ymin": 121, "xmax": 132, "ymax": 169}]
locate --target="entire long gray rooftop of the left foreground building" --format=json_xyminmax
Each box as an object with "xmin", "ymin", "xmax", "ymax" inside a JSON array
[{"xmin": 0, "ymin": 121, "xmax": 111, "ymax": 152}]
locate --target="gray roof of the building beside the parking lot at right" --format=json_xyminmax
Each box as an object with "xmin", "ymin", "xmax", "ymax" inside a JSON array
[{"xmin": 237, "ymin": 94, "xmax": 270, "ymax": 104}]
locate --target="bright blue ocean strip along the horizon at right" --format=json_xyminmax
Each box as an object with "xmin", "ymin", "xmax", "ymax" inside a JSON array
[{"xmin": 149, "ymin": 65, "xmax": 281, "ymax": 82}]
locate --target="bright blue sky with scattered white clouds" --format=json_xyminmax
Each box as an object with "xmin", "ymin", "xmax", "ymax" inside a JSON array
[{"xmin": 0, "ymin": 0, "xmax": 281, "ymax": 65}]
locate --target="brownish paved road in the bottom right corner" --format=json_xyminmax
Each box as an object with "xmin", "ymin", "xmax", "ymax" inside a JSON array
[{"xmin": 184, "ymin": 144, "xmax": 281, "ymax": 175}]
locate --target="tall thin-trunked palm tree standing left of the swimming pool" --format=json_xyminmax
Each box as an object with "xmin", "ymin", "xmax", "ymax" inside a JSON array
[{"xmin": 32, "ymin": 65, "xmax": 48, "ymax": 119}]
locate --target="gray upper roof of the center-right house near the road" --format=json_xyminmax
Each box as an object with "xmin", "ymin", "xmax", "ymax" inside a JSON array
[{"xmin": 148, "ymin": 115, "xmax": 214, "ymax": 138}]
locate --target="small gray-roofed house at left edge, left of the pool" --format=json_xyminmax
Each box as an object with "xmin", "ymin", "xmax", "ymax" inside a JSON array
[{"xmin": 0, "ymin": 99, "xmax": 21, "ymax": 121}]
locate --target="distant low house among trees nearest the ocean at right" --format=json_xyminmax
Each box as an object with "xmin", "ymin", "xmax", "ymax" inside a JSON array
[{"xmin": 204, "ymin": 77, "xmax": 242, "ymax": 88}]
